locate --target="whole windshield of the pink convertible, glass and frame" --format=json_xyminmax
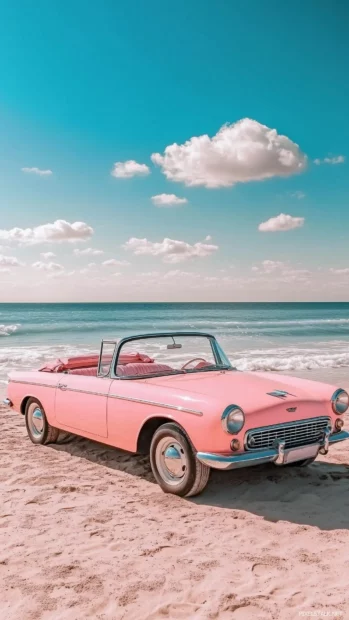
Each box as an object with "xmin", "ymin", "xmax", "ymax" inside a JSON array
[{"xmin": 116, "ymin": 334, "xmax": 232, "ymax": 378}]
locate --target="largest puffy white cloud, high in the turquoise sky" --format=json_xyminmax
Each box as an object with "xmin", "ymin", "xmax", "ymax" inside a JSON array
[{"xmin": 152, "ymin": 118, "xmax": 307, "ymax": 187}]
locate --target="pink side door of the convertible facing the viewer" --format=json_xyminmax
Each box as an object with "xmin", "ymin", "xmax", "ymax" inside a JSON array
[{"xmin": 55, "ymin": 374, "xmax": 111, "ymax": 437}]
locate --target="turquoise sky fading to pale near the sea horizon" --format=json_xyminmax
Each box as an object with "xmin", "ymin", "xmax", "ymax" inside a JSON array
[{"xmin": 0, "ymin": 0, "xmax": 349, "ymax": 301}]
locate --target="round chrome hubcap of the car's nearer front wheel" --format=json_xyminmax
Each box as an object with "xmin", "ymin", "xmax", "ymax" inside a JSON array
[{"xmin": 155, "ymin": 437, "xmax": 188, "ymax": 486}]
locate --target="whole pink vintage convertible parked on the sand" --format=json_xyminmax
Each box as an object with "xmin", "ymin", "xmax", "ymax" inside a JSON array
[{"xmin": 5, "ymin": 332, "xmax": 349, "ymax": 496}]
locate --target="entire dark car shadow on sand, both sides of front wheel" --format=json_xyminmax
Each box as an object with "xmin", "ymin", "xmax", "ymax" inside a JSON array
[{"xmin": 51, "ymin": 437, "xmax": 349, "ymax": 530}]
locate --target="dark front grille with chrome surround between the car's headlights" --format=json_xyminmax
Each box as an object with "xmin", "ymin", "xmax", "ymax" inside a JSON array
[{"xmin": 245, "ymin": 417, "xmax": 331, "ymax": 450}]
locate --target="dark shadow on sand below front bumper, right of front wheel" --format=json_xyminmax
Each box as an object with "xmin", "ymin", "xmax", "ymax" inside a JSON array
[{"xmin": 192, "ymin": 456, "xmax": 349, "ymax": 530}]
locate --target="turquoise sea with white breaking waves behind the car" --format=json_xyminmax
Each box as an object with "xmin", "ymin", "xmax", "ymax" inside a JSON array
[{"xmin": 0, "ymin": 303, "xmax": 349, "ymax": 385}]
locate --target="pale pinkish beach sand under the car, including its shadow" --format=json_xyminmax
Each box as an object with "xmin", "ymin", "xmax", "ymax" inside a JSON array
[{"xmin": 0, "ymin": 400, "xmax": 349, "ymax": 620}]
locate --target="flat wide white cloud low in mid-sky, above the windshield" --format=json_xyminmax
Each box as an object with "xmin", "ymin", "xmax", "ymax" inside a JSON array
[{"xmin": 123, "ymin": 237, "xmax": 218, "ymax": 264}]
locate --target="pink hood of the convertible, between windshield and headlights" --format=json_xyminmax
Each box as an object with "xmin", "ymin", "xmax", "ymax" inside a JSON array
[{"xmin": 147, "ymin": 370, "xmax": 336, "ymax": 410}]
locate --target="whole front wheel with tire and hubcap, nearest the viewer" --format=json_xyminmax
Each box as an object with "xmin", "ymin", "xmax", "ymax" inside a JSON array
[{"xmin": 150, "ymin": 423, "xmax": 210, "ymax": 497}]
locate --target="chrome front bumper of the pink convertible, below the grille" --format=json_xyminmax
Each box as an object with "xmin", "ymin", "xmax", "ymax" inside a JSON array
[{"xmin": 196, "ymin": 430, "xmax": 349, "ymax": 469}]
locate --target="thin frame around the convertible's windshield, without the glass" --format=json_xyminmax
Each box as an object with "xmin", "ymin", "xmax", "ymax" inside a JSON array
[{"xmin": 110, "ymin": 331, "xmax": 234, "ymax": 381}]
